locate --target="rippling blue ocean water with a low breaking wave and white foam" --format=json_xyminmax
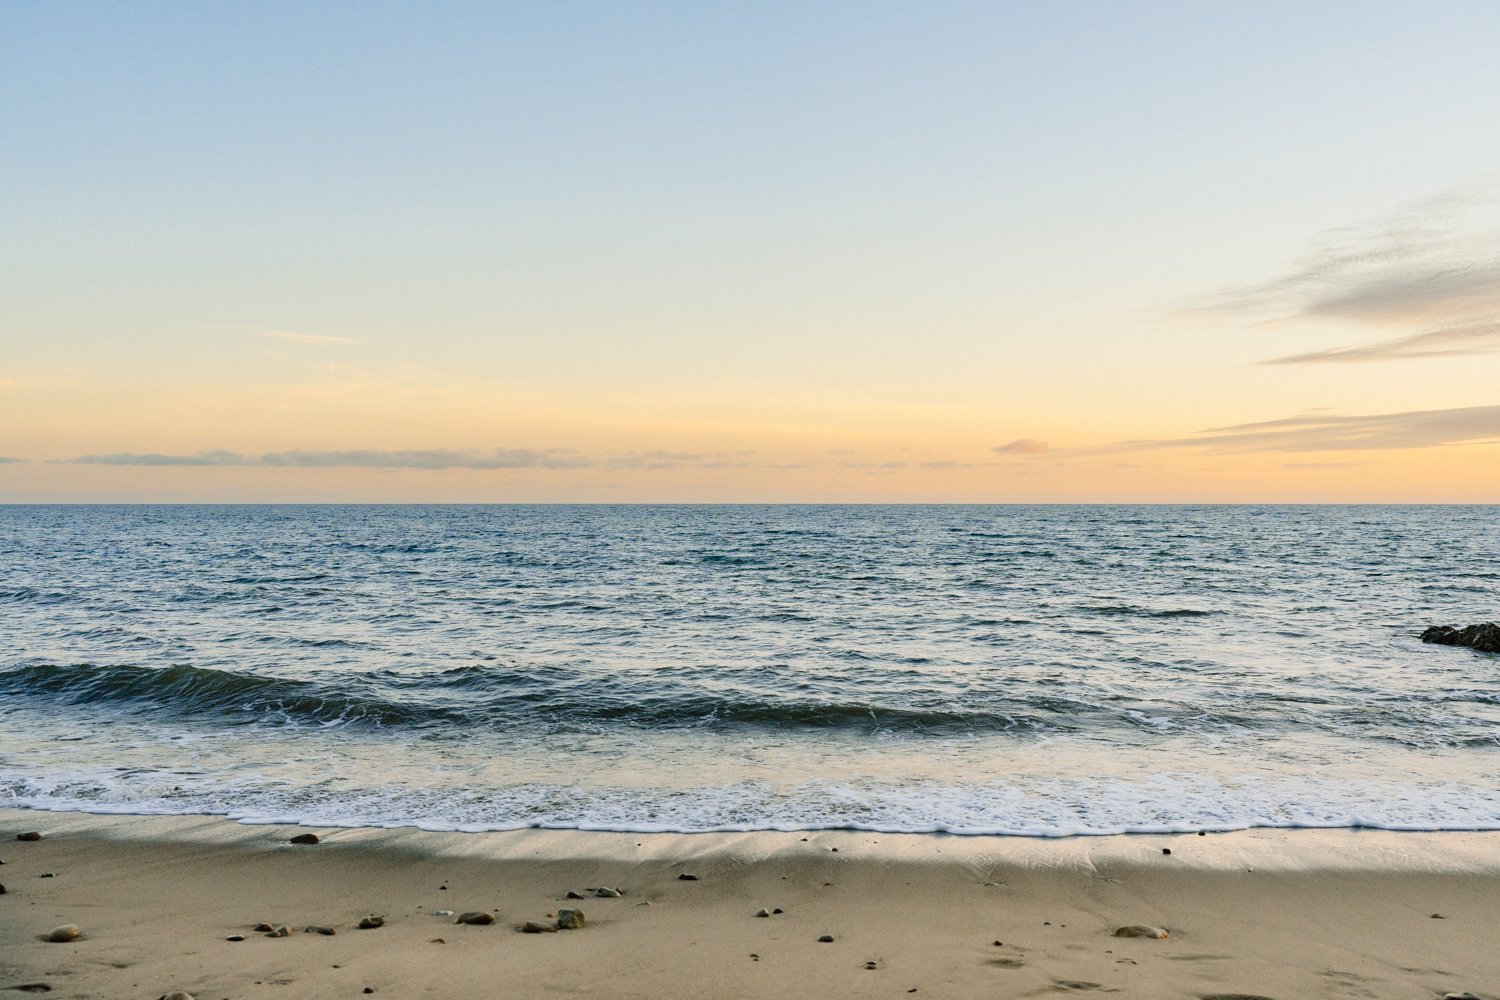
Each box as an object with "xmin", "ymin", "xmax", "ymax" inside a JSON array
[{"xmin": 0, "ymin": 505, "xmax": 1500, "ymax": 835}]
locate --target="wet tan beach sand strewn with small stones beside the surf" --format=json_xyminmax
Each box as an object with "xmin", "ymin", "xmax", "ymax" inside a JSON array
[{"xmin": 0, "ymin": 810, "xmax": 1500, "ymax": 1000}]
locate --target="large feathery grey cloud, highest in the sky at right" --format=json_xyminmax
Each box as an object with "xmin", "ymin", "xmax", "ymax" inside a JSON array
[{"xmin": 1211, "ymin": 186, "xmax": 1500, "ymax": 364}]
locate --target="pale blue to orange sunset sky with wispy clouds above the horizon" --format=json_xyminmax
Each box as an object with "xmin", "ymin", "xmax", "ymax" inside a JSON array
[{"xmin": 0, "ymin": 0, "xmax": 1500, "ymax": 502}]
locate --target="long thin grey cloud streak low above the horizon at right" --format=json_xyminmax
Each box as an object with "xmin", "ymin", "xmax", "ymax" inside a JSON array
[{"xmin": 1104, "ymin": 406, "xmax": 1500, "ymax": 454}]
